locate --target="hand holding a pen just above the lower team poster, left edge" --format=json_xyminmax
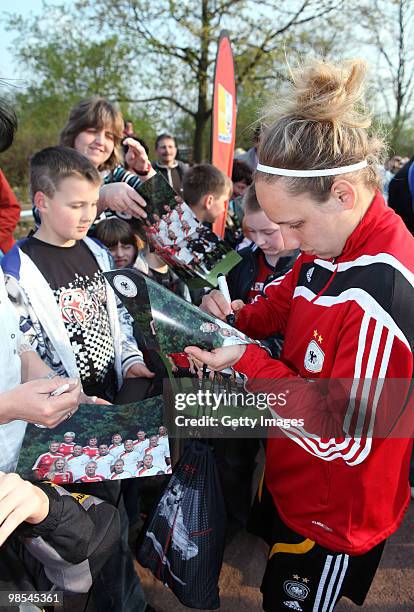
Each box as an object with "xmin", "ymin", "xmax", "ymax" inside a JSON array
[{"xmin": 0, "ymin": 377, "xmax": 81, "ymax": 427}]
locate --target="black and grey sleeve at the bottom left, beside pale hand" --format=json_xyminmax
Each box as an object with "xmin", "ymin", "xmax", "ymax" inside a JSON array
[{"xmin": 16, "ymin": 483, "xmax": 120, "ymax": 591}]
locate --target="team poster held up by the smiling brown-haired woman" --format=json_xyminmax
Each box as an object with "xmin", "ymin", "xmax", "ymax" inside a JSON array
[{"xmin": 134, "ymin": 174, "xmax": 240, "ymax": 287}]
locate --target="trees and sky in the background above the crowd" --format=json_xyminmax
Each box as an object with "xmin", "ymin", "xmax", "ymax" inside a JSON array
[{"xmin": 1, "ymin": 0, "xmax": 413, "ymax": 187}]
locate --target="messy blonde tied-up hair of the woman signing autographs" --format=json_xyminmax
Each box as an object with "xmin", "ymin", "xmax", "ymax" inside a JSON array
[{"xmin": 255, "ymin": 59, "xmax": 384, "ymax": 202}]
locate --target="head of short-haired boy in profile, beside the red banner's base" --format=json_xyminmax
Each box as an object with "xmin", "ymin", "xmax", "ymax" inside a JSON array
[{"xmin": 183, "ymin": 164, "xmax": 233, "ymax": 223}]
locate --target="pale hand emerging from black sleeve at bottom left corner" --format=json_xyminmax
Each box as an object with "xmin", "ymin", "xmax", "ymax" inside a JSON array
[{"xmin": 0, "ymin": 472, "xmax": 49, "ymax": 546}]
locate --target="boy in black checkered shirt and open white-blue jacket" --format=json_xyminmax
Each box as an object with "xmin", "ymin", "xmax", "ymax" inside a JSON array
[{"xmin": 2, "ymin": 147, "xmax": 153, "ymax": 401}]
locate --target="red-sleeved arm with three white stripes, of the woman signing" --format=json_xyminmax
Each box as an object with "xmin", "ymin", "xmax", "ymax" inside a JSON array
[{"xmin": 186, "ymin": 272, "xmax": 414, "ymax": 465}]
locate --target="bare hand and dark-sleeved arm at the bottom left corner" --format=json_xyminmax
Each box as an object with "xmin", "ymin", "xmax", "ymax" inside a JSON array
[{"xmin": 0, "ymin": 472, "xmax": 120, "ymax": 593}]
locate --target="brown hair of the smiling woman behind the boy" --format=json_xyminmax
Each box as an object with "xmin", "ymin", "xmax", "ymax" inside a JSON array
[{"xmin": 60, "ymin": 96, "xmax": 124, "ymax": 170}]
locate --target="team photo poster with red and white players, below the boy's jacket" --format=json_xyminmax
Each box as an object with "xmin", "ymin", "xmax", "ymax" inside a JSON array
[{"xmin": 16, "ymin": 396, "xmax": 171, "ymax": 484}]
